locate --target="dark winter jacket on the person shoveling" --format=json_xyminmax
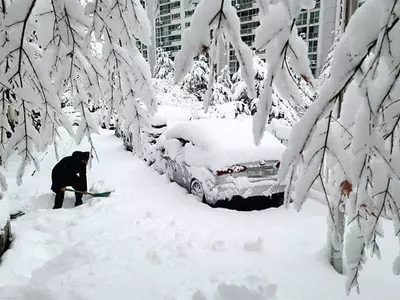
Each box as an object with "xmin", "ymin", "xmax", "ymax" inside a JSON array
[{"xmin": 51, "ymin": 151, "xmax": 90, "ymax": 193}]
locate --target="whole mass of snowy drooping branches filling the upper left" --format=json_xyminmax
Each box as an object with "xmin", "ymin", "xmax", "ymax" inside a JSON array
[{"xmin": 0, "ymin": 0, "xmax": 156, "ymax": 188}]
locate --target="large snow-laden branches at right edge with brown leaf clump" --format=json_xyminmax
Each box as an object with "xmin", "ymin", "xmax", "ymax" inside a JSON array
[{"xmin": 278, "ymin": 0, "xmax": 400, "ymax": 293}]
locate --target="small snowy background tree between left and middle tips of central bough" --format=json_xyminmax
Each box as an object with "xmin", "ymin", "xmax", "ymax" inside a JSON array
[{"xmin": 183, "ymin": 55, "xmax": 210, "ymax": 101}]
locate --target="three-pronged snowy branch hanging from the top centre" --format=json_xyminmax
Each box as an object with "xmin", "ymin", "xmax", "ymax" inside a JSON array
[{"xmin": 174, "ymin": 0, "xmax": 254, "ymax": 111}]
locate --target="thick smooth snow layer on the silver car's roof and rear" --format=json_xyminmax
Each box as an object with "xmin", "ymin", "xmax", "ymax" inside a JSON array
[{"xmin": 164, "ymin": 119, "xmax": 286, "ymax": 170}]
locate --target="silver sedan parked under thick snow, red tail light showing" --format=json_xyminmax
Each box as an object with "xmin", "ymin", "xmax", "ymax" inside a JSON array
[{"xmin": 155, "ymin": 119, "xmax": 285, "ymax": 207}]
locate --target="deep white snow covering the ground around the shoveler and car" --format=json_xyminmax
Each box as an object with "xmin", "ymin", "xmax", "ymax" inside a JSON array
[{"xmin": 0, "ymin": 131, "xmax": 400, "ymax": 300}]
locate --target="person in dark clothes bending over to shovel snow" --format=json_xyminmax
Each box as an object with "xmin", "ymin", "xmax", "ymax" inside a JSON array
[{"xmin": 51, "ymin": 151, "xmax": 90, "ymax": 209}]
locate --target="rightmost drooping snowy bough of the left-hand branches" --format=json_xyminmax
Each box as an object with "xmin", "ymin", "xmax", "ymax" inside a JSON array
[{"xmin": 86, "ymin": 0, "xmax": 157, "ymax": 155}]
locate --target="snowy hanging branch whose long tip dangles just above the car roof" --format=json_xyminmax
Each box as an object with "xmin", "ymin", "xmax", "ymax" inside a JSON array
[{"xmin": 253, "ymin": 0, "xmax": 315, "ymax": 144}]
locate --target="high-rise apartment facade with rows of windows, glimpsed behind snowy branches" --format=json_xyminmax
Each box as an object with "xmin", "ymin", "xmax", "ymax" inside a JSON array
[{"xmin": 152, "ymin": 0, "xmax": 366, "ymax": 76}]
